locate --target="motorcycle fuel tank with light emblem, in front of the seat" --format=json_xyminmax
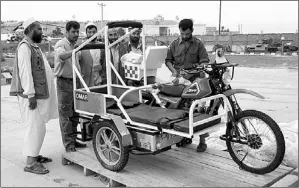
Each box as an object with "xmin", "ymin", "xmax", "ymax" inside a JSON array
[{"xmin": 182, "ymin": 78, "xmax": 212, "ymax": 99}]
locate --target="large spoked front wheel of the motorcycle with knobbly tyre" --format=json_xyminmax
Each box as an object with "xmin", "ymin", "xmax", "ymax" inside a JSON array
[{"xmin": 226, "ymin": 110, "xmax": 285, "ymax": 174}]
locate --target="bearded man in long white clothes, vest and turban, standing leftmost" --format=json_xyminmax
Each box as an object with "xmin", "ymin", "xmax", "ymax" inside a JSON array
[{"xmin": 10, "ymin": 18, "xmax": 58, "ymax": 174}]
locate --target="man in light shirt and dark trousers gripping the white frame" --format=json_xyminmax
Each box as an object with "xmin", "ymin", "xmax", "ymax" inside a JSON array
[{"xmin": 54, "ymin": 21, "xmax": 86, "ymax": 152}]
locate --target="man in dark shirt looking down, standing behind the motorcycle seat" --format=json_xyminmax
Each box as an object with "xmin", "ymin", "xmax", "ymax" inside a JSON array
[{"xmin": 165, "ymin": 19, "xmax": 210, "ymax": 152}]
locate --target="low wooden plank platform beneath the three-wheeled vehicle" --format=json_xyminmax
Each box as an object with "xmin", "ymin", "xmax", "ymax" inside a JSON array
[{"xmin": 62, "ymin": 142, "xmax": 293, "ymax": 187}]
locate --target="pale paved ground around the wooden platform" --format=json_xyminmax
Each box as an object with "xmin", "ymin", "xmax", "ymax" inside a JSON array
[{"xmin": 1, "ymin": 68, "xmax": 298, "ymax": 187}]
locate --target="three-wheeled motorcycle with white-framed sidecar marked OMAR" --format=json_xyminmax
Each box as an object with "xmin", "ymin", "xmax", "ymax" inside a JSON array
[{"xmin": 68, "ymin": 21, "xmax": 284, "ymax": 174}]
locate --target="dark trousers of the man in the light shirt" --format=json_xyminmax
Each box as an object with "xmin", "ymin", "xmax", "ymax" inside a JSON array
[{"xmin": 57, "ymin": 77, "xmax": 80, "ymax": 148}]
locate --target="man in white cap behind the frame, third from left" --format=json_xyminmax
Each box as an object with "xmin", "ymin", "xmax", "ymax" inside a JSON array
[{"xmin": 79, "ymin": 23, "xmax": 106, "ymax": 87}]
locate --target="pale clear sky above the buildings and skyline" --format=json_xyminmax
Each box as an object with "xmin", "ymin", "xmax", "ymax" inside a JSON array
[{"xmin": 1, "ymin": 1, "xmax": 298, "ymax": 34}]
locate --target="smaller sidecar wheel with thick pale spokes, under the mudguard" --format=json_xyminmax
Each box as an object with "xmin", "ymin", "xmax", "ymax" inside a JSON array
[{"xmin": 92, "ymin": 121, "xmax": 129, "ymax": 172}]
